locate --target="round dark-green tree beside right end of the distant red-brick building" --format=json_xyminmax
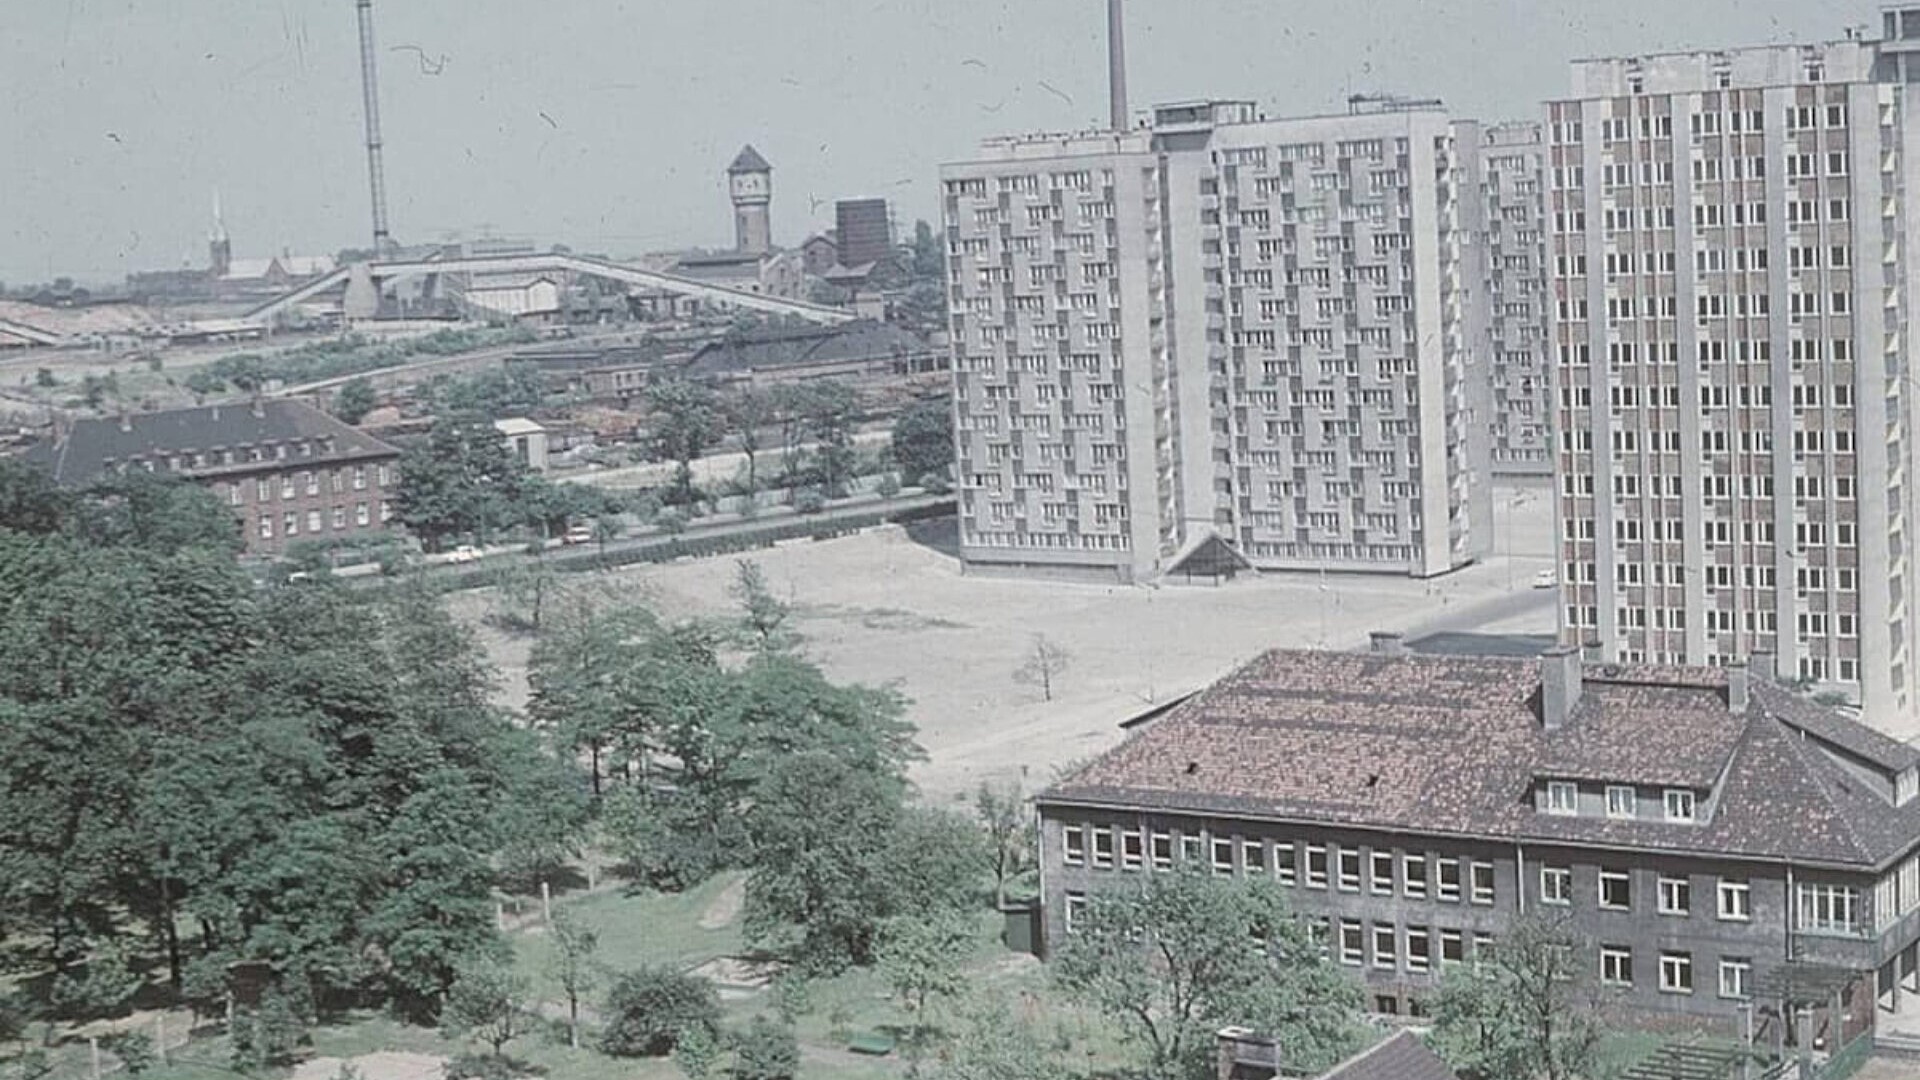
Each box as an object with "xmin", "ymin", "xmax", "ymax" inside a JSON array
[{"xmin": 394, "ymin": 413, "xmax": 526, "ymax": 552}]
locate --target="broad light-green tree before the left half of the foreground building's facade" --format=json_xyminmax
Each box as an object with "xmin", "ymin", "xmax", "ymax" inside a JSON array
[{"xmin": 1054, "ymin": 872, "xmax": 1361, "ymax": 1078}]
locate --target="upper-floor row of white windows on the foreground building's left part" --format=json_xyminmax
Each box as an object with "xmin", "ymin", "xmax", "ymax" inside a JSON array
[{"xmin": 1060, "ymin": 824, "xmax": 1494, "ymax": 905}]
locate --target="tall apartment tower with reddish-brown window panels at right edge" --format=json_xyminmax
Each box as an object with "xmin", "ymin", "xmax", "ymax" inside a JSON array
[{"xmin": 1546, "ymin": 10, "xmax": 1920, "ymax": 736}]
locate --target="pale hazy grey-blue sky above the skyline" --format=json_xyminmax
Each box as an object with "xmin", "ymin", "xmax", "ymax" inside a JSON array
[{"xmin": 0, "ymin": 0, "xmax": 1878, "ymax": 282}]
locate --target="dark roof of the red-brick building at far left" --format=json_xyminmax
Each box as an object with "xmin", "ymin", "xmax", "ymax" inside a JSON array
[{"xmin": 25, "ymin": 400, "xmax": 399, "ymax": 484}]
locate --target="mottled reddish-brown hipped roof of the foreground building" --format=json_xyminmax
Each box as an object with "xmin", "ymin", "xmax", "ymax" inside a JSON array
[{"xmin": 1039, "ymin": 650, "xmax": 1920, "ymax": 867}]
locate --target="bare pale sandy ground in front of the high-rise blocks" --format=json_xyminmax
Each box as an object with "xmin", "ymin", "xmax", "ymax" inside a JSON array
[{"xmin": 453, "ymin": 486, "xmax": 1555, "ymax": 799}]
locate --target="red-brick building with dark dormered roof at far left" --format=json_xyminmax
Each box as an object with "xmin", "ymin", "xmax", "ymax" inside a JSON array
[{"xmin": 25, "ymin": 400, "xmax": 399, "ymax": 555}]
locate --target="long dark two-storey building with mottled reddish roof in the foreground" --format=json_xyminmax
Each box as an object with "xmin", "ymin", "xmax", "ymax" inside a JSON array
[{"xmin": 1035, "ymin": 634, "xmax": 1920, "ymax": 1038}]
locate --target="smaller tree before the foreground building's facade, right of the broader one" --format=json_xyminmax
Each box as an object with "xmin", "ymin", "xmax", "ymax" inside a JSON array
[{"xmin": 1432, "ymin": 915, "xmax": 1607, "ymax": 1080}]
